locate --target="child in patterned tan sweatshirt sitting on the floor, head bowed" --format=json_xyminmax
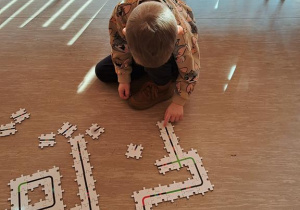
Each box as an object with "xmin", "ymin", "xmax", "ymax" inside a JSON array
[{"xmin": 96, "ymin": 0, "xmax": 200, "ymax": 125}]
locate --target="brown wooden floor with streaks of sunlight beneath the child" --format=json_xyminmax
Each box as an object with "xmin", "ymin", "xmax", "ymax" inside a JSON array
[{"xmin": 0, "ymin": 0, "xmax": 300, "ymax": 210}]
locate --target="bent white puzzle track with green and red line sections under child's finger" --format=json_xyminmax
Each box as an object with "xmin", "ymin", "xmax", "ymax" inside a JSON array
[{"xmin": 132, "ymin": 121, "xmax": 214, "ymax": 210}]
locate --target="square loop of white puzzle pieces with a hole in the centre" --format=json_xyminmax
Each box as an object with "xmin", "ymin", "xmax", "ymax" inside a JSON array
[{"xmin": 8, "ymin": 166, "xmax": 66, "ymax": 210}]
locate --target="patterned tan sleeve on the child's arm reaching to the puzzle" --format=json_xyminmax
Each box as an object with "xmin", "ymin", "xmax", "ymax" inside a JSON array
[{"xmin": 168, "ymin": 0, "xmax": 200, "ymax": 105}]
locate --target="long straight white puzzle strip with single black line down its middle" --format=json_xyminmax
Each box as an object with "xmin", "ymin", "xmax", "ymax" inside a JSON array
[{"xmin": 68, "ymin": 134, "xmax": 100, "ymax": 210}]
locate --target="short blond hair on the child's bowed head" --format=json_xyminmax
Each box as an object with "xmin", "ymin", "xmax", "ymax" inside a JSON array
[{"xmin": 126, "ymin": 1, "xmax": 177, "ymax": 68}]
